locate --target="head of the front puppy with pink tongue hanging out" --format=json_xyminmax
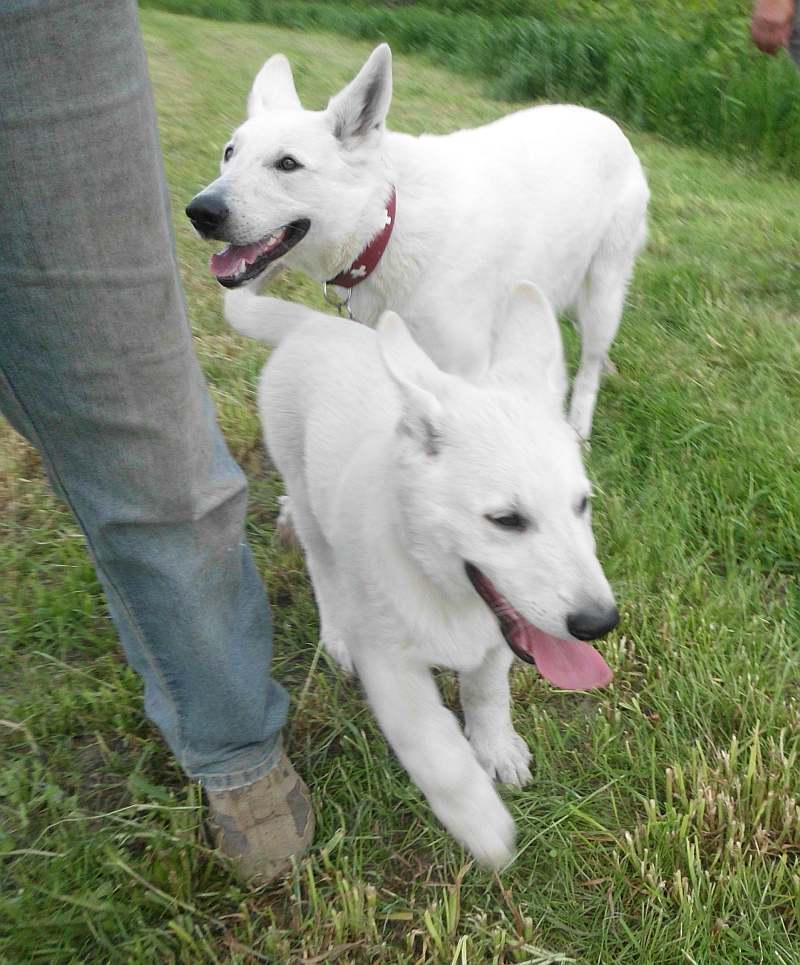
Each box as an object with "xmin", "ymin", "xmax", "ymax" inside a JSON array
[{"xmin": 379, "ymin": 282, "xmax": 618, "ymax": 689}]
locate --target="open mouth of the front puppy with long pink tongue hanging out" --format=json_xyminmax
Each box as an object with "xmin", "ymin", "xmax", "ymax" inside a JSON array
[{"xmin": 465, "ymin": 563, "xmax": 614, "ymax": 690}]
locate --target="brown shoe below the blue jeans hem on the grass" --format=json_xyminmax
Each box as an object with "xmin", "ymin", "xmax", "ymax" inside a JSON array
[{"xmin": 206, "ymin": 754, "xmax": 314, "ymax": 885}]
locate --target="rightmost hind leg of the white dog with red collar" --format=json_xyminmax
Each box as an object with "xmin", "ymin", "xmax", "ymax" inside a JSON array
[{"xmin": 569, "ymin": 179, "xmax": 648, "ymax": 439}]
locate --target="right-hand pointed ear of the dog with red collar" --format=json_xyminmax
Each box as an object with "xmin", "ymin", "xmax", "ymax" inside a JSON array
[{"xmin": 327, "ymin": 44, "xmax": 392, "ymax": 147}]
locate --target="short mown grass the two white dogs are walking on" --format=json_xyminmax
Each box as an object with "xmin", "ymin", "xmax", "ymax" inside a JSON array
[{"xmin": 0, "ymin": 11, "xmax": 800, "ymax": 965}]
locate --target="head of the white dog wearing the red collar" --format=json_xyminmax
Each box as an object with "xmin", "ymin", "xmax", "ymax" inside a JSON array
[{"xmin": 186, "ymin": 44, "xmax": 392, "ymax": 288}]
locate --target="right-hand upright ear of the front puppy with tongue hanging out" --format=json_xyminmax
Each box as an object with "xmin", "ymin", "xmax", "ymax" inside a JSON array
[{"xmin": 491, "ymin": 281, "xmax": 567, "ymax": 408}]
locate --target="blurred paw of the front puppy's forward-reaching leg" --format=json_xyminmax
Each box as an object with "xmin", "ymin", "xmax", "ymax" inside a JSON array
[{"xmin": 431, "ymin": 772, "xmax": 517, "ymax": 870}]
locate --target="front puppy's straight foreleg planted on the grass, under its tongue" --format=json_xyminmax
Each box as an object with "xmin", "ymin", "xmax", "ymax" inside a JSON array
[{"xmin": 458, "ymin": 645, "xmax": 531, "ymax": 787}]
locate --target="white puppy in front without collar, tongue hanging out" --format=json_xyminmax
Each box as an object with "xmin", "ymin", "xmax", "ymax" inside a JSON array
[{"xmin": 226, "ymin": 282, "xmax": 618, "ymax": 867}]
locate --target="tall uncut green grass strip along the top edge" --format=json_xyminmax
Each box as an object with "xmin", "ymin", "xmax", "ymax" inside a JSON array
[{"xmin": 145, "ymin": 0, "xmax": 800, "ymax": 175}]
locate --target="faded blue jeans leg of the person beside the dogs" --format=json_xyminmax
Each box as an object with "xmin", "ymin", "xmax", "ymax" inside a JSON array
[{"xmin": 0, "ymin": 0, "xmax": 288, "ymax": 790}]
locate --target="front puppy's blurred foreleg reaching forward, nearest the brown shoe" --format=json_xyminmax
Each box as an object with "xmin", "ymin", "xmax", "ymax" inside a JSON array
[{"xmin": 356, "ymin": 643, "xmax": 515, "ymax": 868}]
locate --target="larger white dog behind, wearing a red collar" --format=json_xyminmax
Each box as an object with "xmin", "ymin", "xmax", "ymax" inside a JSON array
[{"xmin": 186, "ymin": 44, "xmax": 648, "ymax": 438}]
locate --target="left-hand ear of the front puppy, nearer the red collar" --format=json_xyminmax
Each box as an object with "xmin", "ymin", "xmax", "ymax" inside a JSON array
[{"xmin": 378, "ymin": 312, "xmax": 447, "ymax": 456}]
